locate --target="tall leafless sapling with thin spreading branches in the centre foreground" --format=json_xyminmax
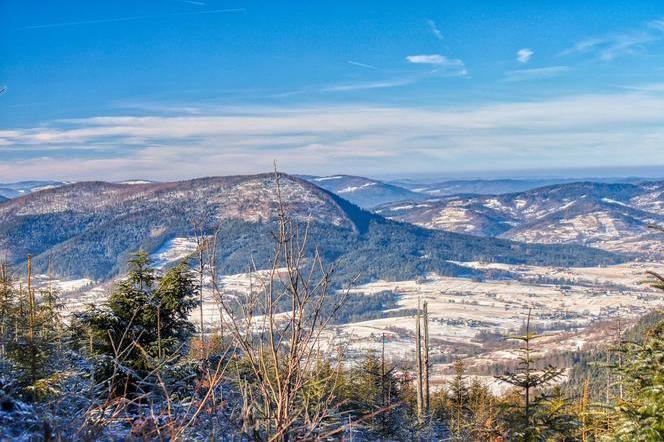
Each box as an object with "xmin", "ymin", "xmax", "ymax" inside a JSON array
[{"xmin": 212, "ymin": 170, "xmax": 356, "ymax": 441}]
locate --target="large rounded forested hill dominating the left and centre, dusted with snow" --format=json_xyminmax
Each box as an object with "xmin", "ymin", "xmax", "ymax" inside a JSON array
[{"xmin": 0, "ymin": 174, "xmax": 624, "ymax": 279}]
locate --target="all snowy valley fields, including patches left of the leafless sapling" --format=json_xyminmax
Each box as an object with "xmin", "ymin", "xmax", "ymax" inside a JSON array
[{"xmin": 36, "ymin": 260, "xmax": 664, "ymax": 388}]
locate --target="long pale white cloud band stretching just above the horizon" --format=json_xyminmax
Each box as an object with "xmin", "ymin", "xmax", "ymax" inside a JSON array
[{"xmin": 0, "ymin": 93, "xmax": 664, "ymax": 180}]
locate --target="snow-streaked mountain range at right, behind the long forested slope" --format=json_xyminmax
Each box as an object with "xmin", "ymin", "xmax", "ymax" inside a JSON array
[{"xmin": 375, "ymin": 181, "xmax": 664, "ymax": 256}]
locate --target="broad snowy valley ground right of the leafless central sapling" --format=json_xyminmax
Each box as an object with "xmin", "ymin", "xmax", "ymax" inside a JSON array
[{"xmin": 326, "ymin": 262, "xmax": 664, "ymax": 372}]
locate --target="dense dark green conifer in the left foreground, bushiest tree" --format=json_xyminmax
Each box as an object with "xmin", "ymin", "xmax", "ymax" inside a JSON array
[{"xmin": 77, "ymin": 251, "xmax": 199, "ymax": 393}]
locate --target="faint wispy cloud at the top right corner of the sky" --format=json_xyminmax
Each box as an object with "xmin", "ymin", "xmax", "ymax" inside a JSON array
[{"xmin": 559, "ymin": 19, "xmax": 664, "ymax": 61}]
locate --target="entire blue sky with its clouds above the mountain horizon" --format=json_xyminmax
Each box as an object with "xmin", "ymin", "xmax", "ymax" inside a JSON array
[{"xmin": 0, "ymin": 0, "xmax": 664, "ymax": 182}]
